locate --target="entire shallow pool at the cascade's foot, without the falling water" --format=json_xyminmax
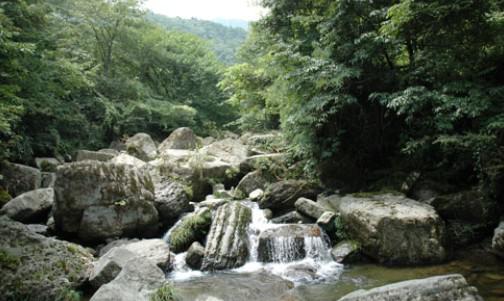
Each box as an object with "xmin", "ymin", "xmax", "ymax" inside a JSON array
[{"xmin": 175, "ymin": 243, "xmax": 504, "ymax": 301}]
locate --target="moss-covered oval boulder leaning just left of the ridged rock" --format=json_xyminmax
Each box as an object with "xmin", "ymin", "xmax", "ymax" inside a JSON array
[{"xmin": 168, "ymin": 208, "xmax": 212, "ymax": 253}]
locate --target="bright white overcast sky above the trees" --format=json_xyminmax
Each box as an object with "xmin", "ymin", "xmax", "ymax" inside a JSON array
[{"xmin": 145, "ymin": 0, "xmax": 263, "ymax": 21}]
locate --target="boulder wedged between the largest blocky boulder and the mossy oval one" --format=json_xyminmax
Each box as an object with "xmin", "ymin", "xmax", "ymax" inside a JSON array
[{"xmin": 155, "ymin": 181, "xmax": 194, "ymax": 225}]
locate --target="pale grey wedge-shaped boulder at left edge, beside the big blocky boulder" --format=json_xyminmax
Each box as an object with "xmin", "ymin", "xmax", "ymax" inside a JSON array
[{"xmin": 0, "ymin": 188, "xmax": 54, "ymax": 223}]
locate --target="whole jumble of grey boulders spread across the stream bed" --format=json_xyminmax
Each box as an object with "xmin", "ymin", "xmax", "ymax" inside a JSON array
[{"xmin": 0, "ymin": 128, "xmax": 496, "ymax": 301}]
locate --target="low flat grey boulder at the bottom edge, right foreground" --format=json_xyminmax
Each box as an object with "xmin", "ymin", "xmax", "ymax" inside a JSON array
[{"xmin": 339, "ymin": 274, "xmax": 483, "ymax": 301}]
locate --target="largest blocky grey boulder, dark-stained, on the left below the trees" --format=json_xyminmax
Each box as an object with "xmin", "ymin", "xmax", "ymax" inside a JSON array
[{"xmin": 54, "ymin": 161, "xmax": 158, "ymax": 242}]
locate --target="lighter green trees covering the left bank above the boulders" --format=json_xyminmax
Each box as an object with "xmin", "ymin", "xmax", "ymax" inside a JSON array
[{"xmin": 0, "ymin": 0, "xmax": 240, "ymax": 162}]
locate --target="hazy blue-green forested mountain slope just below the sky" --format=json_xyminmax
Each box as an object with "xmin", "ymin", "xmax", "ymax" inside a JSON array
[{"xmin": 146, "ymin": 12, "xmax": 247, "ymax": 65}]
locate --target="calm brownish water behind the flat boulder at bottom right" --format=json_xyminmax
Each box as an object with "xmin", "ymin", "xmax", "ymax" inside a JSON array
[{"xmin": 285, "ymin": 247, "xmax": 504, "ymax": 301}]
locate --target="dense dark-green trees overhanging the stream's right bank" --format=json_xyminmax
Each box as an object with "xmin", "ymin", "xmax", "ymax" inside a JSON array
[{"xmin": 220, "ymin": 0, "xmax": 504, "ymax": 188}]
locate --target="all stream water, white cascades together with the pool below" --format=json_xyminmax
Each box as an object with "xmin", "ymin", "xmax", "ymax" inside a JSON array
[{"xmin": 165, "ymin": 202, "xmax": 504, "ymax": 301}]
